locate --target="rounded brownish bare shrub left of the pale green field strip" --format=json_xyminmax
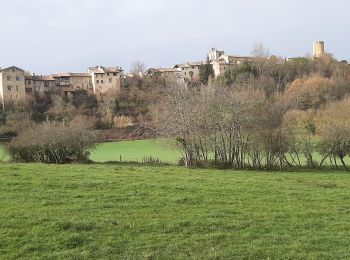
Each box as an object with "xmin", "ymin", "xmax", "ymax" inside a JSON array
[{"xmin": 7, "ymin": 124, "xmax": 97, "ymax": 164}]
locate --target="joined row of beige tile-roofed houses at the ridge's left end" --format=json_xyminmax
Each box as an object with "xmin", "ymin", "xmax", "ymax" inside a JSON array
[{"xmin": 0, "ymin": 66, "xmax": 124, "ymax": 108}]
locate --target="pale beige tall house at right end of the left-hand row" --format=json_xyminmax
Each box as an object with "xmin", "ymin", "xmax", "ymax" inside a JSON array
[{"xmin": 88, "ymin": 66, "xmax": 124, "ymax": 102}]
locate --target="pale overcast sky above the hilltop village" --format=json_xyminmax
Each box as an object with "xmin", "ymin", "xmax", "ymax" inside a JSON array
[{"xmin": 0, "ymin": 0, "xmax": 350, "ymax": 74}]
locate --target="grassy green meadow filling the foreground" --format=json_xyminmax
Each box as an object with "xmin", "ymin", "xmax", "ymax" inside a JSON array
[{"xmin": 0, "ymin": 164, "xmax": 350, "ymax": 259}]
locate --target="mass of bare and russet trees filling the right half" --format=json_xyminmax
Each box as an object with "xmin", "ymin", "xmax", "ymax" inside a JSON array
[{"xmin": 153, "ymin": 54, "xmax": 350, "ymax": 170}]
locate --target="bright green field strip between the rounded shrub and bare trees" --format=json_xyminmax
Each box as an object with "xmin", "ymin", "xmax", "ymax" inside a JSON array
[{"xmin": 90, "ymin": 139, "xmax": 181, "ymax": 163}]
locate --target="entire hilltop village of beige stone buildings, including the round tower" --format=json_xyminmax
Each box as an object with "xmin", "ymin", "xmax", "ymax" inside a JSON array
[{"xmin": 0, "ymin": 42, "xmax": 346, "ymax": 108}]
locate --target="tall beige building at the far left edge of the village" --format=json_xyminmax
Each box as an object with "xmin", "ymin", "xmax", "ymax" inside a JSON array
[{"xmin": 0, "ymin": 66, "xmax": 26, "ymax": 108}]
